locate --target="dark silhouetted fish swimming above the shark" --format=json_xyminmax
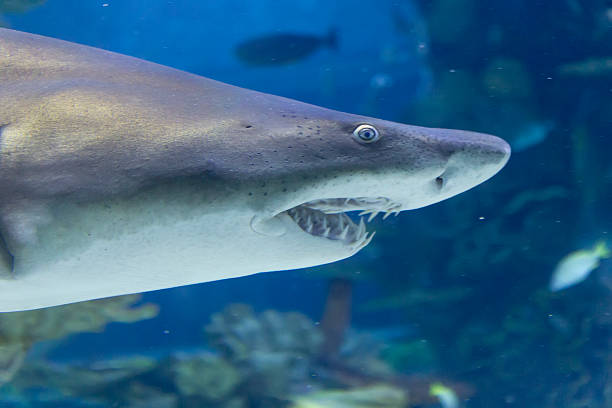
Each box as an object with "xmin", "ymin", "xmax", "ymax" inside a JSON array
[{"xmin": 236, "ymin": 29, "xmax": 338, "ymax": 66}]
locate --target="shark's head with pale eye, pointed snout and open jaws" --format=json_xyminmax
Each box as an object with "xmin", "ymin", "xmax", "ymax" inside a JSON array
[{"xmin": 221, "ymin": 96, "xmax": 510, "ymax": 266}]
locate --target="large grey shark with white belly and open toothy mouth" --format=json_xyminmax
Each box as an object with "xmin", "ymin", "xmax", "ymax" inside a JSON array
[{"xmin": 0, "ymin": 29, "xmax": 510, "ymax": 311}]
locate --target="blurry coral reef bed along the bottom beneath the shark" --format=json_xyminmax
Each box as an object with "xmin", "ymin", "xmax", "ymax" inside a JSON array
[{"xmin": 2, "ymin": 304, "xmax": 472, "ymax": 408}]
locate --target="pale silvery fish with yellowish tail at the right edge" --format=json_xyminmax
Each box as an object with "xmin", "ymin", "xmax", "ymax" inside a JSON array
[{"xmin": 549, "ymin": 241, "xmax": 611, "ymax": 292}]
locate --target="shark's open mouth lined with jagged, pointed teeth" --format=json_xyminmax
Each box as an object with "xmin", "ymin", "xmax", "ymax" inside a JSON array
[{"xmin": 286, "ymin": 197, "xmax": 401, "ymax": 251}]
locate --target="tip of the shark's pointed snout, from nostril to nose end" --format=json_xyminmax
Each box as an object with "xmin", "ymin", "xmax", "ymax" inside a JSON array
[{"xmin": 435, "ymin": 129, "xmax": 510, "ymax": 196}]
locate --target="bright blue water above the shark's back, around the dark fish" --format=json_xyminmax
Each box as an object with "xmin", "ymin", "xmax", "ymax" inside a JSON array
[{"xmin": 9, "ymin": 0, "xmax": 428, "ymax": 119}]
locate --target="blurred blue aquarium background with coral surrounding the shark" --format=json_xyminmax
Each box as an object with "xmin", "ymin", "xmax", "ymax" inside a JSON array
[{"xmin": 0, "ymin": 0, "xmax": 612, "ymax": 408}]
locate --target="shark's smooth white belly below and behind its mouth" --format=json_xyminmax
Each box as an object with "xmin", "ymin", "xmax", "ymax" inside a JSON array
[{"xmin": 0, "ymin": 190, "xmax": 352, "ymax": 311}]
